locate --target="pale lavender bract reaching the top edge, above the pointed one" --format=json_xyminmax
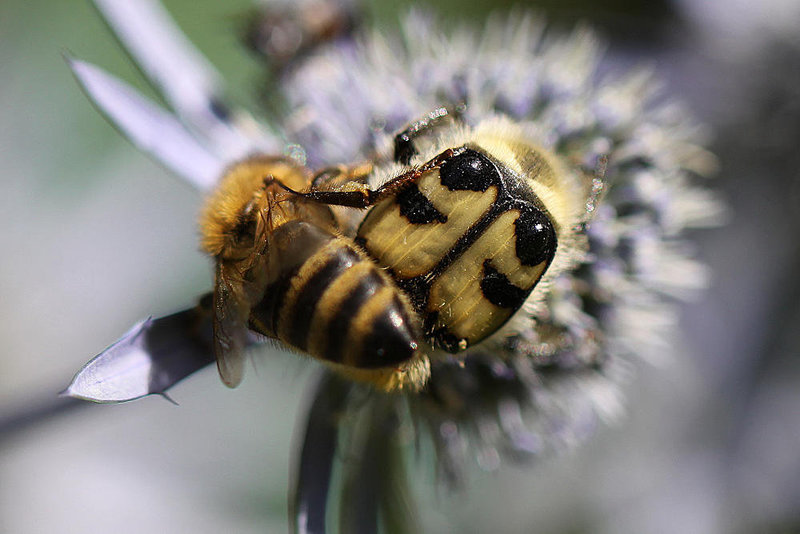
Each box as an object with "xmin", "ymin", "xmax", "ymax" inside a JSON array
[{"xmin": 94, "ymin": 0, "xmax": 280, "ymax": 162}]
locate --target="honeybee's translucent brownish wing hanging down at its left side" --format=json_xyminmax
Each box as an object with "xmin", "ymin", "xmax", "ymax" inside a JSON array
[{"xmin": 213, "ymin": 263, "xmax": 250, "ymax": 388}]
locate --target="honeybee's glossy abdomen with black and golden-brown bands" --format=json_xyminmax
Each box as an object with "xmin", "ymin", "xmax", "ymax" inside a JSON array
[{"xmin": 250, "ymin": 221, "xmax": 417, "ymax": 369}]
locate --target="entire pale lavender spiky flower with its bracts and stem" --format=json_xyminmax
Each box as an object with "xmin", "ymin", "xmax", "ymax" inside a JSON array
[{"xmin": 68, "ymin": 0, "xmax": 721, "ymax": 532}]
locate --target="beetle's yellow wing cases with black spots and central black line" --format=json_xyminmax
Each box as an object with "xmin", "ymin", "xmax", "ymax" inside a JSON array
[{"xmin": 356, "ymin": 147, "xmax": 556, "ymax": 352}]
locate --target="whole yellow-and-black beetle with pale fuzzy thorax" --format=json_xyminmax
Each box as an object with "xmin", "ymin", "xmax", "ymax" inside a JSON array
[{"xmin": 290, "ymin": 108, "xmax": 596, "ymax": 362}]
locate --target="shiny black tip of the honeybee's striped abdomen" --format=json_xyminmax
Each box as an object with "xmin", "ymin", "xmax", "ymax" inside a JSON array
[{"xmin": 355, "ymin": 298, "xmax": 417, "ymax": 369}]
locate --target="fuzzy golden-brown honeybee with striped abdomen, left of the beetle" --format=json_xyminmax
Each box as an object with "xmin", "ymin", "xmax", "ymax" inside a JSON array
[{"xmin": 200, "ymin": 156, "xmax": 430, "ymax": 391}]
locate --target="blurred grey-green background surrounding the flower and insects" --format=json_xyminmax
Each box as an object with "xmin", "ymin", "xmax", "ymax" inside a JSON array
[{"xmin": 0, "ymin": 0, "xmax": 800, "ymax": 534}]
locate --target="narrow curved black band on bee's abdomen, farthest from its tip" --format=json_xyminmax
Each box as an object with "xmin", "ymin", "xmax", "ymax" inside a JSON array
[{"xmin": 288, "ymin": 247, "xmax": 361, "ymax": 350}]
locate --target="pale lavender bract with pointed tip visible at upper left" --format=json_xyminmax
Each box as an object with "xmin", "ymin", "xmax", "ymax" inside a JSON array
[{"xmin": 67, "ymin": 58, "xmax": 227, "ymax": 190}]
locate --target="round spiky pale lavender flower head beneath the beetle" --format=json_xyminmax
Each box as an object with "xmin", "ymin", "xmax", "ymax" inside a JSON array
[{"xmin": 274, "ymin": 12, "xmax": 721, "ymax": 494}]
